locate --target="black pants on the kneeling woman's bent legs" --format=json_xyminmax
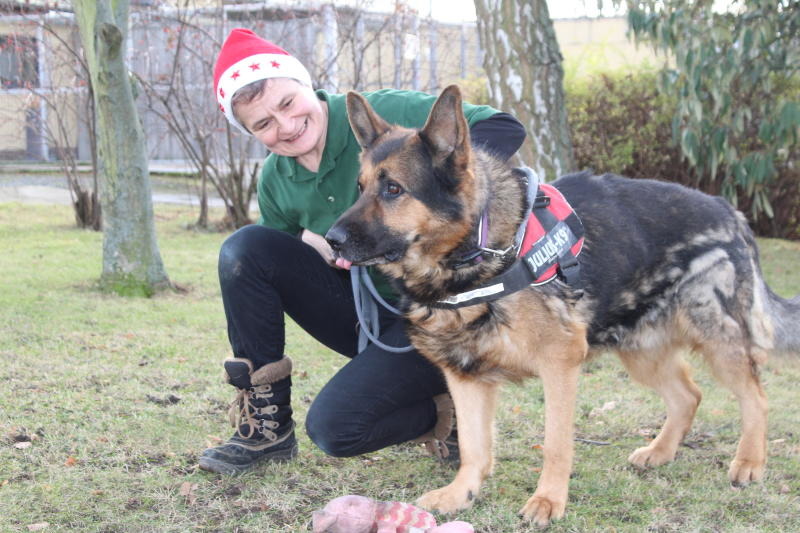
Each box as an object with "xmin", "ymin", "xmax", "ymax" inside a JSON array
[{"xmin": 219, "ymin": 225, "xmax": 447, "ymax": 457}]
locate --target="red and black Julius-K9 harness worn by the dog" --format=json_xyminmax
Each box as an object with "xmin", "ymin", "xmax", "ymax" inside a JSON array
[{"xmin": 435, "ymin": 168, "xmax": 584, "ymax": 309}]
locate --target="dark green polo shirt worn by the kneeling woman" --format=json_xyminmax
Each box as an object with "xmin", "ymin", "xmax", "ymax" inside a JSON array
[{"xmin": 258, "ymin": 89, "xmax": 498, "ymax": 298}]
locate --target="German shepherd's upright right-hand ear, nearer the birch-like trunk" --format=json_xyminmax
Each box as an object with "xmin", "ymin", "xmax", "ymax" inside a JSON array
[{"xmin": 419, "ymin": 85, "xmax": 469, "ymax": 166}]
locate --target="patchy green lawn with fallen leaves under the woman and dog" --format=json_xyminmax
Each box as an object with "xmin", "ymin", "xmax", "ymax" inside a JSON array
[{"xmin": 0, "ymin": 203, "xmax": 800, "ymax": 533}]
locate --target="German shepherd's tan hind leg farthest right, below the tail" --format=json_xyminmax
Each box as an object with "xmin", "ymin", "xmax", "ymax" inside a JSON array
[{"xmin": 701, "ymin": 345, "xmax": 767, "ymax": 485}]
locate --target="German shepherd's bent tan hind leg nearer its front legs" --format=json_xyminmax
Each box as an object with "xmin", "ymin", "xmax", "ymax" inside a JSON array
[{"xmin": 619, "ymin": 347, "xmax": 703, "ymax": 467}]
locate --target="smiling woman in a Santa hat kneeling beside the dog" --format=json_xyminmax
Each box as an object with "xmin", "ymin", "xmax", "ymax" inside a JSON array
[{"xmin": 200, "ymin": 29, "xmax": 525, "ymax": 473}]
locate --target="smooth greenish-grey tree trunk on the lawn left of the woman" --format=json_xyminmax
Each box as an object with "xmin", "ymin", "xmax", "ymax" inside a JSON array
[{"xmin": 73, "ymin": 0, "xmax": 170, "ymax": 296}]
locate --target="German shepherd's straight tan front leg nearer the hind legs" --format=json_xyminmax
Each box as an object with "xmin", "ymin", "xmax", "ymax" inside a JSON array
[{"xmin": 521, "ymin": 358, "xmax": 580, "ymax": 526}]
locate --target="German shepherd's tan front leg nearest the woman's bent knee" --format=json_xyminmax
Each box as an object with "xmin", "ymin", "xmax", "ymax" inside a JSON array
[{"xmin": 417, "ymin": 369, "xmax": 497, "ymax": 513}]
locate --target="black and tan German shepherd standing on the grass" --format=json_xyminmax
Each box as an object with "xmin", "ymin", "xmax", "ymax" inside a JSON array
[{"xmin": 327, "ymin": 86, "xmax": 800, "ymax": 525}]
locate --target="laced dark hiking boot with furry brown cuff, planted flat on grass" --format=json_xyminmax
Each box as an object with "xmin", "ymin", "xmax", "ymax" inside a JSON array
[{"xmin": 200, "ymin": 357, "xmax": 297, "ymax": 474}]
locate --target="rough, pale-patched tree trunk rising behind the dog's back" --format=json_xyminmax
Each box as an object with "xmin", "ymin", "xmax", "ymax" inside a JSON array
[{"xmin": 475, "ymin": 0, "xmax": 574, "ymax": 180}]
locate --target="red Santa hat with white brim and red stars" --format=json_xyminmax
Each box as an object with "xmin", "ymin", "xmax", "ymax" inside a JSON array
[{"xmin": 214, "ymin": 28, "xmax": 311, "ymax": 133}]
